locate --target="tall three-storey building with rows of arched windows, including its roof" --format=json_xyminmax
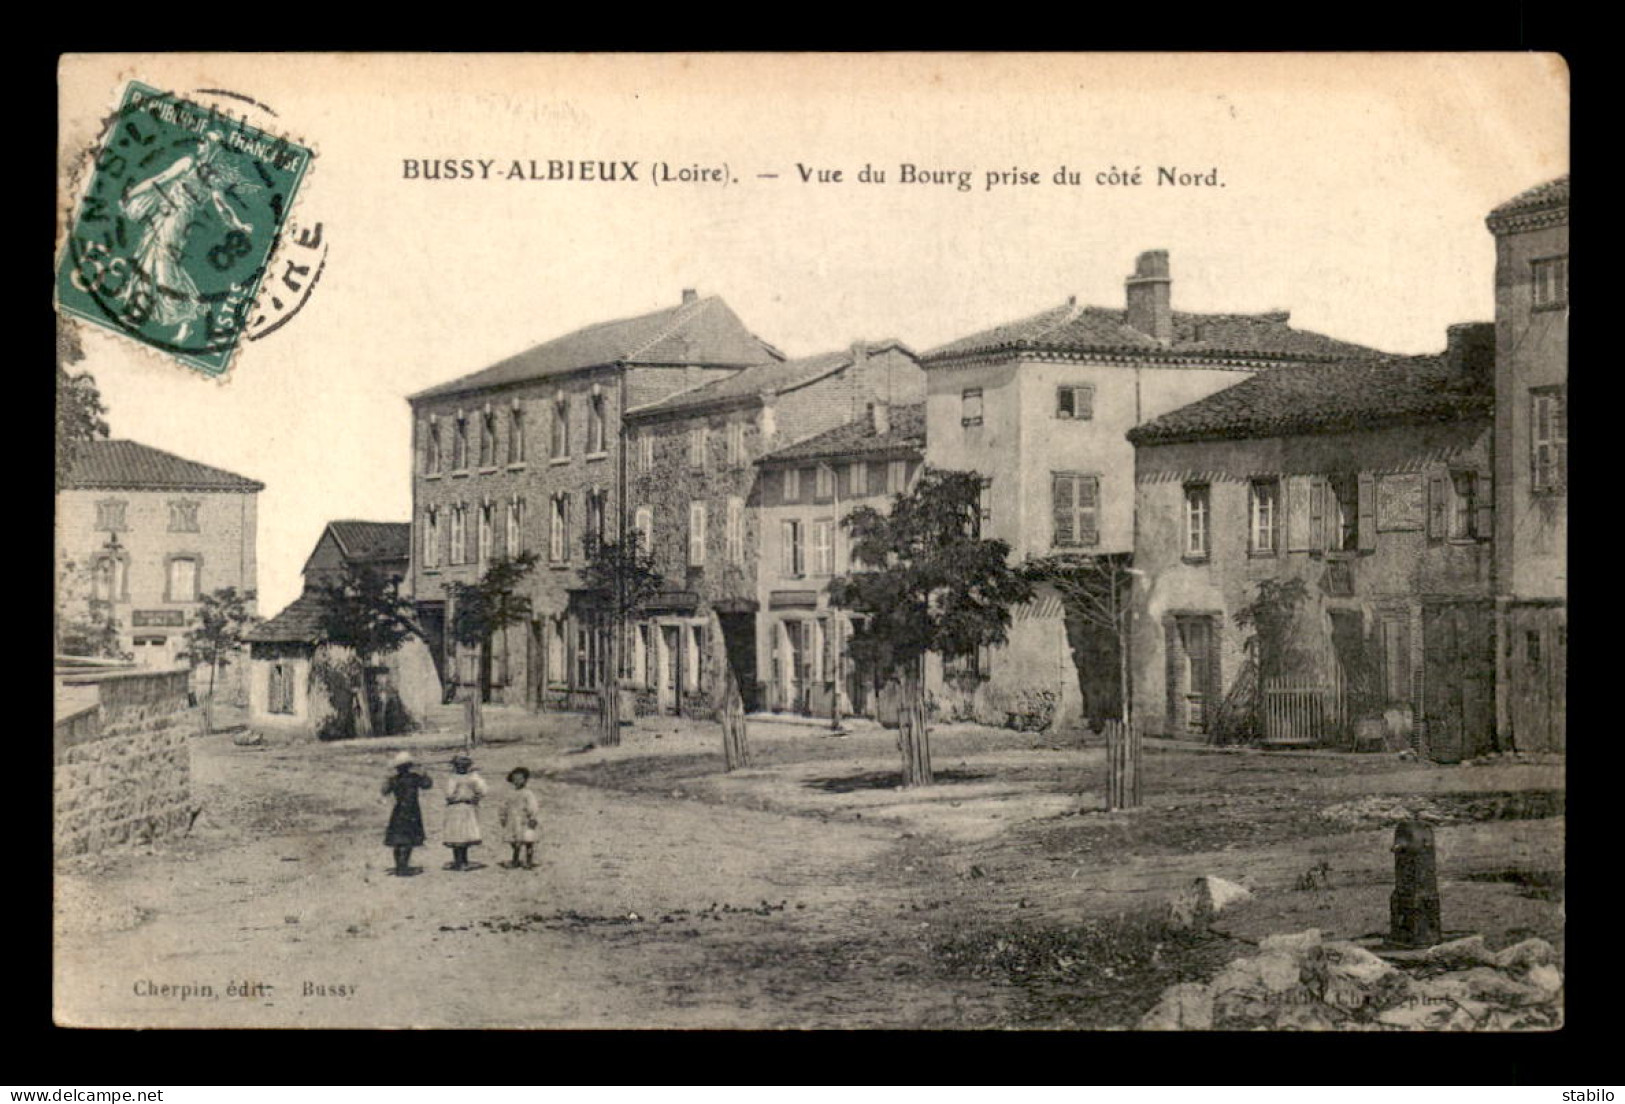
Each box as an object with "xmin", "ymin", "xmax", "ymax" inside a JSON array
[{"xmin": 408, "ymin": 291, "xmax": 783, "ymax": 707}]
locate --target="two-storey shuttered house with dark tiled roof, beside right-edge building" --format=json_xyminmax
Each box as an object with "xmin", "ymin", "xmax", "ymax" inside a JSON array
[{"xmin": 1128, "ymin": 324, "xmax": 1498, "ymax": 761}]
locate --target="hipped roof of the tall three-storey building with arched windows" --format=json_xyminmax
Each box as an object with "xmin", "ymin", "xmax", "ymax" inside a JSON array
[{"xmin": 411, "ymin": 296, "xmax": 778, "ymax": 400}]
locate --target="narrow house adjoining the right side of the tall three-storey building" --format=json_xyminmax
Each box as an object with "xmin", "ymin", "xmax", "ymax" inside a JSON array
[{"xmin": 622, "ymin": 341, "xmax": 925, "ymax": 712}]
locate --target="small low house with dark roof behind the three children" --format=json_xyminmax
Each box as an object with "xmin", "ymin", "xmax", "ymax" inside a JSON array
[{"xmin": 247, "ymin": 520, "xmax": 440, "ymax": 735}]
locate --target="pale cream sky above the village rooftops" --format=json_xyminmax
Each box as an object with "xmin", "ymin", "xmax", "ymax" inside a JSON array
[{"xmin": 59, "ymin": 54, "xmax": 1568, "ymax": 615}]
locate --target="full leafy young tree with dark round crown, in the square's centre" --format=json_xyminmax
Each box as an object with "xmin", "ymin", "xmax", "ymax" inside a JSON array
[{"xmin": 830, "ymin": 468, "xmax": 1032, "ymax": 785}]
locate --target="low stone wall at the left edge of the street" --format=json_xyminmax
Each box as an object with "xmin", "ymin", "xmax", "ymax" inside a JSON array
[{"xmin": 55, "ymin": 670, "xmax": 193, "ymax": 858}]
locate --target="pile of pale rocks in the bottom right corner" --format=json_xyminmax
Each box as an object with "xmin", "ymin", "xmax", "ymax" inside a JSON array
[{"xmin": 1139, "ymin": 928, "xmax": 1563, "ymax": 1031}]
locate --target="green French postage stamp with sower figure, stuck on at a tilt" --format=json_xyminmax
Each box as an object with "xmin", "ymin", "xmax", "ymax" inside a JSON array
[{"xmin": 57, "ymin": 81, "xmax": 312, "ymax": 376}]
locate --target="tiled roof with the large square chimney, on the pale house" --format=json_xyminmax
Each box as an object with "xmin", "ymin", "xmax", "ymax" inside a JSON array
[{"xmin": 921, "ymin": 302, "xmax": 1381, "ymax": 364}]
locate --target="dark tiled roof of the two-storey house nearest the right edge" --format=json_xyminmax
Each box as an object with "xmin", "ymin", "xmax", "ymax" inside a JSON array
[{"xmin": 1128, "ymin": 354, "xmax": 1495, "ymax": 446}]
